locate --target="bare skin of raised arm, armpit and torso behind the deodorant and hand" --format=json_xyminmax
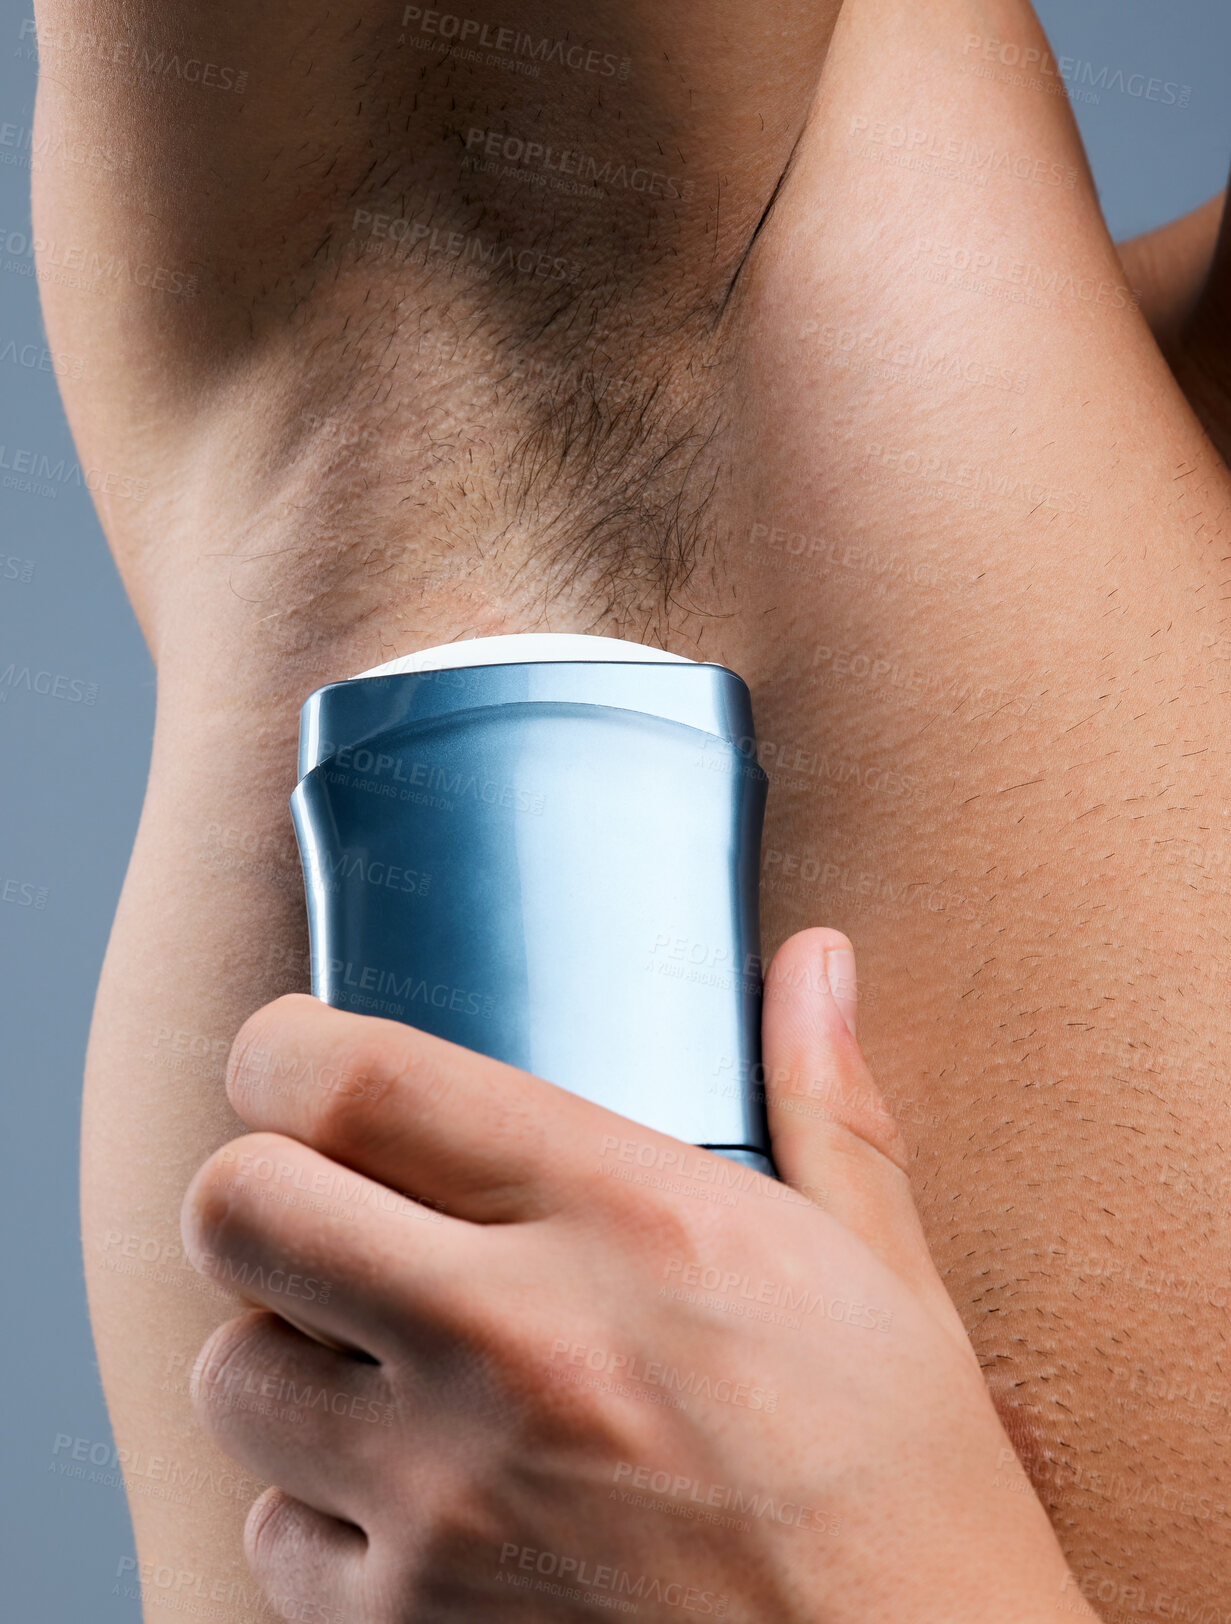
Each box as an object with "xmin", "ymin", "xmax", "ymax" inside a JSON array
[{"xmin": 24, "ymin": 0, "xmax": 1231, "ymax": 1619}]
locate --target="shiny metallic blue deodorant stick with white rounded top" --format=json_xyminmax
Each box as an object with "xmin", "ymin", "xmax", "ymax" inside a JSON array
[{"xmin": 291, "ymin": 635, "xmax": 773, "ymax": 1176}]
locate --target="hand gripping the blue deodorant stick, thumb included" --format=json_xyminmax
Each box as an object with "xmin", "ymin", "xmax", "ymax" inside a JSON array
[{"xmin": 184, "ymin": 931, "xmax": 1093, "ymax": 1624}]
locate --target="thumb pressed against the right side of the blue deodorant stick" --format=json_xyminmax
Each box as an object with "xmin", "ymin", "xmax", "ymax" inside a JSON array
[{"xmin": 762, "ymin": 929, "xmax": 965, "ymax": 1340}]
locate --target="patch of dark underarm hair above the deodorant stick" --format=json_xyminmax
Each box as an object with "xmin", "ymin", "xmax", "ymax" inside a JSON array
[{"xmin": 241, "ymin": 106, "xmax": 743, "ymax": 635}]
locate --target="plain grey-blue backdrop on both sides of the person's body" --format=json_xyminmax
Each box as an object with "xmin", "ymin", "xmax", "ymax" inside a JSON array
[{"xmin": 0, "ymin": 0, "xmax": 1231, "ymax": 1624}]
